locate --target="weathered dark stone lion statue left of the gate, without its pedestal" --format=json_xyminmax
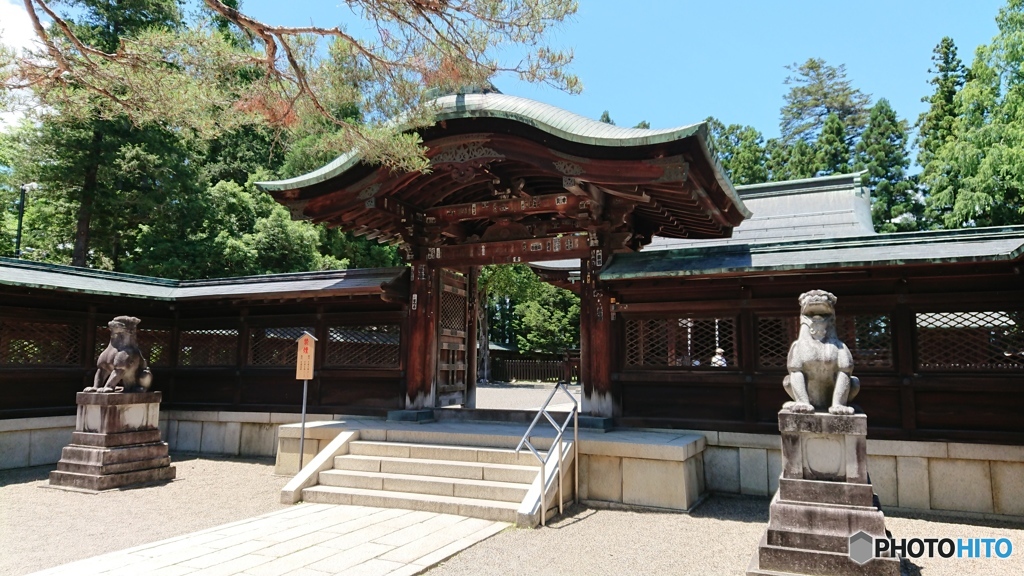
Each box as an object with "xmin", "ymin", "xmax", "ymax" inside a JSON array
[{"xmin": 83, "ymin": 316, "xmax": 153, "ymax": 393}]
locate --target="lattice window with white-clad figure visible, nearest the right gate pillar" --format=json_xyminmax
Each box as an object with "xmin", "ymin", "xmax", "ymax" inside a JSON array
[{"xmin": 626, "ymin": 318, "xmax": 736, "ymax": 368}]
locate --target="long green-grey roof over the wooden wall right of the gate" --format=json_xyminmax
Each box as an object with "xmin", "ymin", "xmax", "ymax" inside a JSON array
[{"xmin": 600, "ymin": 227, "xmax": 1024, "ymax": 282}]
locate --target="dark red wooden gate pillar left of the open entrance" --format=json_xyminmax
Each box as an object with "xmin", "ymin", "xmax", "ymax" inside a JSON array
[{"xmin": 406, "ymin": 260, "xmax": 440, "ymax": 410}]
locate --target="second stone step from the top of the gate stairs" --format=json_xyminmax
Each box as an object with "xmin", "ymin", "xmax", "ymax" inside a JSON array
[{"xmin": 334, "ymin": 454, "xmax": 540, "ymax": 484}]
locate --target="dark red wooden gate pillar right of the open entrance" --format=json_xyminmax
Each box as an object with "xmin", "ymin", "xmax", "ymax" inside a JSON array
[{"xmin": 580, "ymin": 248, "xmax": 622, "ymax": 417}]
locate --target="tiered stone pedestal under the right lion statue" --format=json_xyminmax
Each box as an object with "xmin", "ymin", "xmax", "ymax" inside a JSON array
[{"xmin": 746, "ymin": 410, "xmax": 900, "ymax": 576}]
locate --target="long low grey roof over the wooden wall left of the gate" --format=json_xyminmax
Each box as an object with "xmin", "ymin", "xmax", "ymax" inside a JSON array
[{"xmin": 0, "ymin": 258, "xmax": 408, "ymax": 301}]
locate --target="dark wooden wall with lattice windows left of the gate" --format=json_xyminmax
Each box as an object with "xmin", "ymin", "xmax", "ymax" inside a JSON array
[{"xmin": 0, "ymin": 288, "xmax": 407, "ymax": 418}]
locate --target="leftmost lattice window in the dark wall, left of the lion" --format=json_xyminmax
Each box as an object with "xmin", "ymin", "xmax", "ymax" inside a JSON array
[{"xmin": 0, "ymin": 320, "xmax": 82, "ymax": 366}]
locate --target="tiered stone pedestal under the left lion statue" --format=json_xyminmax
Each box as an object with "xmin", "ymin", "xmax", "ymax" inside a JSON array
[{"xmin": 50, "ymin": 392, "xmax": 175, "ymax": 491}]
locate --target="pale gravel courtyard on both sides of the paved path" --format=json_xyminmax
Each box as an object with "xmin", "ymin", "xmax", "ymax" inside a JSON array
[{"xmin": 0, "ymin": 454, "xmax": 1024, "ymax": 576}]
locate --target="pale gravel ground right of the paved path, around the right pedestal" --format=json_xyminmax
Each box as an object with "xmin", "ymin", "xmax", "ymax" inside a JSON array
[{"xmin": 426, "ymin": 497, "xmax": 1024, "ymax": 576}]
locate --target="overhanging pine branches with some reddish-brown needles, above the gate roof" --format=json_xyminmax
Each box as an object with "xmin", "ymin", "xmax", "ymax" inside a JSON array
[{"xmin": 8, "ymin": 0, "xmax": 581, "ymax": 169}]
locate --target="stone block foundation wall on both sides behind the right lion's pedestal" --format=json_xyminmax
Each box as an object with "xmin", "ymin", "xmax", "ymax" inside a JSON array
[{"xmin": 695, "ymin": 431, "xmax": 1024, "ymax": 517}]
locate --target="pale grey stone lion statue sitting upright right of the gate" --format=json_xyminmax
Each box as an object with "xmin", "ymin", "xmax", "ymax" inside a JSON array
[{"xmin": 782, "ymin": 290, "xmax": 860, "ymax": 414}]
